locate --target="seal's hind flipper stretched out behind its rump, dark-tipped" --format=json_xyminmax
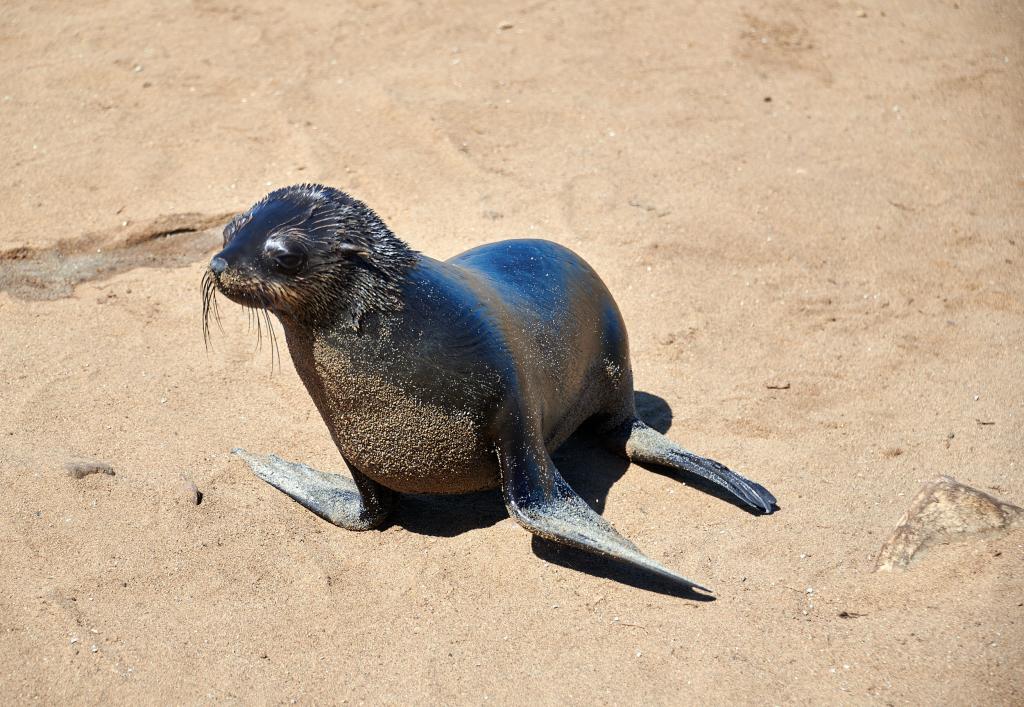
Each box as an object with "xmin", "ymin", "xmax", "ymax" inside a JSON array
[{"xmin": 626, "ymin": 419, "xmax": 775, "ymax": 513}]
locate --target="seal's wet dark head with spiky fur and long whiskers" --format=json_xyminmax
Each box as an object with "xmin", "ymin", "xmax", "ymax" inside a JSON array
[{"xmin": 203, "ymin": 184, "xmax": 416, "ymax": 330}]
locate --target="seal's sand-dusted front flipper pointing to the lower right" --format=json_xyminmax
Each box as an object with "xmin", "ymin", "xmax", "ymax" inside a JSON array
[{"xmin": 498, "ymin": 434, "xmax": 711, "ymax": 591}]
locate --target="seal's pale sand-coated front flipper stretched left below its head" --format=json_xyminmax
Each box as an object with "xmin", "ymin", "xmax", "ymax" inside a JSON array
[{"xmin": 231, "ymin": 449, "xmax": 392, "ymax": 531}]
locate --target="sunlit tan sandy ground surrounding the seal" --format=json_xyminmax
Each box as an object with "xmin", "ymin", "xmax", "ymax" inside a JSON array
[{"xmin": 0, "ymin": 0, "xmax": 1024, "ymax": 705}]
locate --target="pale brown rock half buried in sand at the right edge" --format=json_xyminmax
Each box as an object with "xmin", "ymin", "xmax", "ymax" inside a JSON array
[{"xmin": 874, "ymin": 475, "xmax": 1024, "ymax": 572}]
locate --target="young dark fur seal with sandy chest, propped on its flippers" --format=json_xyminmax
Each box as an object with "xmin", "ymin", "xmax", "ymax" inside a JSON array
[{"xmin": 203, "ymin": 184, "xmax": 775, "ymax": 590}]
